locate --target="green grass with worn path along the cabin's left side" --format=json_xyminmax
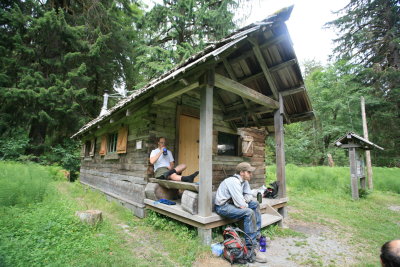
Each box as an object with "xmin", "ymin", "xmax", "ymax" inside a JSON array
[{"xmin": 0, "ymin": 162, "xmax": 208, "ymax": 266}]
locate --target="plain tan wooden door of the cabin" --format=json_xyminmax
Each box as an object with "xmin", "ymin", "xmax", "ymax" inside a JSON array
[{"xmin": 178, "ymin": 115, "xmax": 200, "ymax": 182}]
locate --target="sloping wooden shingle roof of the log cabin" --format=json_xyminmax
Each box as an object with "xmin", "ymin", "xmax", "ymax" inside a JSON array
[{"xmin": 72, "ymin": 6, "xmax": 314, "ymax": 138}]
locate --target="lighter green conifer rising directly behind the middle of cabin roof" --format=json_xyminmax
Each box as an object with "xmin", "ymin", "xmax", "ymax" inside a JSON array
[{"xmin": 136, "ymin": 0, "xmax": 240, "ymax": 81}]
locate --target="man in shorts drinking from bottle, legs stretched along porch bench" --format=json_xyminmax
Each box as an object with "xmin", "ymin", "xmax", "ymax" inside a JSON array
[{"xmin": 150, "ymin": 137, "xmax": 199, "ymax": 183}]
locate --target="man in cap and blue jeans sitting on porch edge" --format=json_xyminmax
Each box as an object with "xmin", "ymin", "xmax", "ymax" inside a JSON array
[{"xmin": 215, "ymin": 162, "xmax": 267, "ymax": 262}]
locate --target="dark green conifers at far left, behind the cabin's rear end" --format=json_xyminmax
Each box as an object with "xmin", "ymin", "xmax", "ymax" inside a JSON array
[{"xmin": 0, "ymin": 0, "xmax": 140, "ymax": 161}]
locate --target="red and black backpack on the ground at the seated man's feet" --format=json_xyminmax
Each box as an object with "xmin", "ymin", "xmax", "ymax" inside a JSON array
[{"xmin": 222, "ymin": 226, "xmax": 254, "ymax": 264}]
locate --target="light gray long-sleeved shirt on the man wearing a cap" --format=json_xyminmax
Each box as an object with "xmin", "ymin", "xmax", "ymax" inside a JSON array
[{"xmin": 215, "ymin": 174, "xmax": 253, "ymax": 208}]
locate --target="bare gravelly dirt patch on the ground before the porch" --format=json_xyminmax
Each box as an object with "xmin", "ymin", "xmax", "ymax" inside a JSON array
[{"xmin": 194, "ymin": 207, "xmax": 357, "ymax": 267}]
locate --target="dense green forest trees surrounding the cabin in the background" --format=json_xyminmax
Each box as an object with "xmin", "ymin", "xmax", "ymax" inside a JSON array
[{"xmin": 0, "ymin": 0, "xmax": 400, "ymax": 178}]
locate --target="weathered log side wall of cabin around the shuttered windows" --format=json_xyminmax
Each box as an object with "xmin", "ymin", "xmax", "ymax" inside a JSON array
[{"xmin": 80, "ymin": 102, "xmax": 151, "ymax": 217}]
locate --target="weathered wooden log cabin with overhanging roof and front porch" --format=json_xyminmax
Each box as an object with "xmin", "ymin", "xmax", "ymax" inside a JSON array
[{"xmin": 73, "ymin": 8, "xmax": 314, "ymax": 243}]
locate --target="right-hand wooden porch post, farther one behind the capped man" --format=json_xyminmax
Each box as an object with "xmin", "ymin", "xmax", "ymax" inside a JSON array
[{"xmin": 274, "ymin": 94, "xmax": 286, "ymax": 220}]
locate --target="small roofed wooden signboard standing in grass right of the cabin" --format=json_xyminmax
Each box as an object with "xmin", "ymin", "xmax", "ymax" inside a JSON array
[{"xmin": 335, "ymin": 132, "xmax": 383, "ymax": 199}]
